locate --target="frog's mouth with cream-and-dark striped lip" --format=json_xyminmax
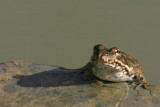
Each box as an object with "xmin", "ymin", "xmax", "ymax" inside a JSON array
[{"xmin": 102, "ymin": 56, "xmax": 133, "ymax": 73}]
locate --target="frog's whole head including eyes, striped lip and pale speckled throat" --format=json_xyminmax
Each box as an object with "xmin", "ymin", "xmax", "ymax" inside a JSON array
[{"xmin": 90, "ymin": 44, "xmax": 135, "ymax": 82}]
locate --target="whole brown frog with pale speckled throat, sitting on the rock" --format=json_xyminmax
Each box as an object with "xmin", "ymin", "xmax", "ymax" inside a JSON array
[{"xmin": 88, "ymin": 44, "xmax": 149, "ymax": 90}]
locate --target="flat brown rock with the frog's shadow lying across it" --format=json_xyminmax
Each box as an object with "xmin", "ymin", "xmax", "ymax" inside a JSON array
[{"xmin": 0, "ymin": 61, "xmax": 160, "ymax": 107}]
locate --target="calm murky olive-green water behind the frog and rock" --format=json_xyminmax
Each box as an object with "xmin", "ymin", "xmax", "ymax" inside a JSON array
[{"xmin": 0, "ymin": 0, "xmax": 160, "ymax": 84}]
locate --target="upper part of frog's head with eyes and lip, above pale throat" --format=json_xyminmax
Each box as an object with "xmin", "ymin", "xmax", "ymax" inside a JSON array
[{"xmin": 91, "ymin": 44, "xmax": 133, "ymax": 72}]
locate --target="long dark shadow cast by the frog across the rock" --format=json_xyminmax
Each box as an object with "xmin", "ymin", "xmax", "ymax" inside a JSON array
[{"xmin": 14, "ymin": 68, "xmax": 89, "ymax": 87}]
